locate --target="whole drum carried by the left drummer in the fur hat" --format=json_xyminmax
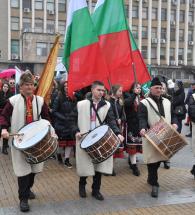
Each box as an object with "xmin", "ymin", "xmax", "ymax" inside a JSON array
[{"xmin": 13, "ymin": 119, "xmax": 58, "ymax": 164}]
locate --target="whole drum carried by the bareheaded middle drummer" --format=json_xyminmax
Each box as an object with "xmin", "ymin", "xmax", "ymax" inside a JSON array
[{"xmin": 81, "ymin": 125, "xmax": 120, "ymax": 164}]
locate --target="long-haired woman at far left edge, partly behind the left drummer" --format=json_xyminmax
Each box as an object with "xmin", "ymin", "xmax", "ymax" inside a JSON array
[{"xmin": 0, "ymin": 83, "xmax": 13, "ymax": 155}]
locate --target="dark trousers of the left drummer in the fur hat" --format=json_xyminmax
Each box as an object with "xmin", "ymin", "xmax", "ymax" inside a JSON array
[{"xmin": 18, "ymin": 173, "xmax": 35, "ymax": 200}]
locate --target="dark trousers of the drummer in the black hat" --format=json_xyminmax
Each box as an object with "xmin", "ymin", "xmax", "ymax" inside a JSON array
[{"xmin": 147, "ymin": 161, "xmax": 161, "ymax": 186}]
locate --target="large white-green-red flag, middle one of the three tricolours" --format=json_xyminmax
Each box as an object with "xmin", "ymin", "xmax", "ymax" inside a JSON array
[{"xmin": 92, "ymin": 0, "xmax": 134, "ymax": 90}]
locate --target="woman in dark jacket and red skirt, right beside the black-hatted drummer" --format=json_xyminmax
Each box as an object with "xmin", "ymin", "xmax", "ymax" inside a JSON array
[{"xmin": 124, "ymin": 83, "xmax": 142, "ymax": 176}]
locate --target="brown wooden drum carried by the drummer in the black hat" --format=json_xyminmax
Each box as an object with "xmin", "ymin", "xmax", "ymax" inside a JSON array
[{"xmin": 145, "ymin": 118, "xmax": 188, "ymax": 159}]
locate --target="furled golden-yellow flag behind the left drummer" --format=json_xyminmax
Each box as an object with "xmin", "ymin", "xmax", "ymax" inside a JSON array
[{"xmin": 36, "ymin": 35, "xmax": 60, "ymax": 104}]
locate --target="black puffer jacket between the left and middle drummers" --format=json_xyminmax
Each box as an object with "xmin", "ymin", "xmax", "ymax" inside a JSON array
[{"xmin": 52, "ymin": 94, "xmax": 76, "ymax": 141}]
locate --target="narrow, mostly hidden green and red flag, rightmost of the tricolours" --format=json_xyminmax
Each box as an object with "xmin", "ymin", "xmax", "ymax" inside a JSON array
[{"xmin": 129, "ymin": 29, "xmax": 151, "ymax": 87}]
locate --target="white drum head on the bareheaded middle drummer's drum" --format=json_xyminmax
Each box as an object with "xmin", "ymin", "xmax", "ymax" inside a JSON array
[{"xmin": 81, "ymin": 125, "xmax": 109, "ymax": 149}]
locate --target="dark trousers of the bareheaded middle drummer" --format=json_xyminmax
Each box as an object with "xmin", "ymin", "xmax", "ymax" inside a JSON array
[{"xmin": 79, "ymin": 172, "xmax": 102, "ymax": 193}]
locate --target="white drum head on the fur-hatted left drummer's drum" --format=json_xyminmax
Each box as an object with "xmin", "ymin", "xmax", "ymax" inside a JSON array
[{"xmin": 13, "ymin": 119, "xmax": 50, "ymax": 150}]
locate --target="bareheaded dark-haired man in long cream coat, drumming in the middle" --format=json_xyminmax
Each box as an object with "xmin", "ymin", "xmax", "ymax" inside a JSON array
[{"xmin": 74, "ymin": 81, "xmax": 124, "ymax": 201}]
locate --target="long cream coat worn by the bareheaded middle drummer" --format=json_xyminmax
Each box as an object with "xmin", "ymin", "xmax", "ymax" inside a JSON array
[{"xmin": 74, "ymin": 99, "xmax": 120, "ymax": 176}]
